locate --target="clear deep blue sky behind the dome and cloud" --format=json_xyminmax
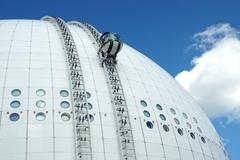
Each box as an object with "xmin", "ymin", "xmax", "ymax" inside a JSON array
[{"xmin": 0, "ymin": 0, "xmax": 240, "ymax": 160}]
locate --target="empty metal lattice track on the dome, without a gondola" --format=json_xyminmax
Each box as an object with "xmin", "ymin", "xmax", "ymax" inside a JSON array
[{"xmin": 42, "ymin": 16, "xmax": 92, "ymax": 160}]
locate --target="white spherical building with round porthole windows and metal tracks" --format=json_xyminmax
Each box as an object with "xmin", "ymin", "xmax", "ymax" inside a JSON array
[{"xmin": 0, "ymin": 17, "xmax": 229, "ymax": 160}]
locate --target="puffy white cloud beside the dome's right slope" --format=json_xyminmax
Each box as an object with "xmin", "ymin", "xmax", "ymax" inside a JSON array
[{"xmin": 175, "ymin": 24, "xmax": 240, "ymax": 122}]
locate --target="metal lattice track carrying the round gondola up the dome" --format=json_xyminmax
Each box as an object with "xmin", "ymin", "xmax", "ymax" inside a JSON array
[{"xmin": 69, "ymin": 21, "xmax": 137, "ymax": 160}]
